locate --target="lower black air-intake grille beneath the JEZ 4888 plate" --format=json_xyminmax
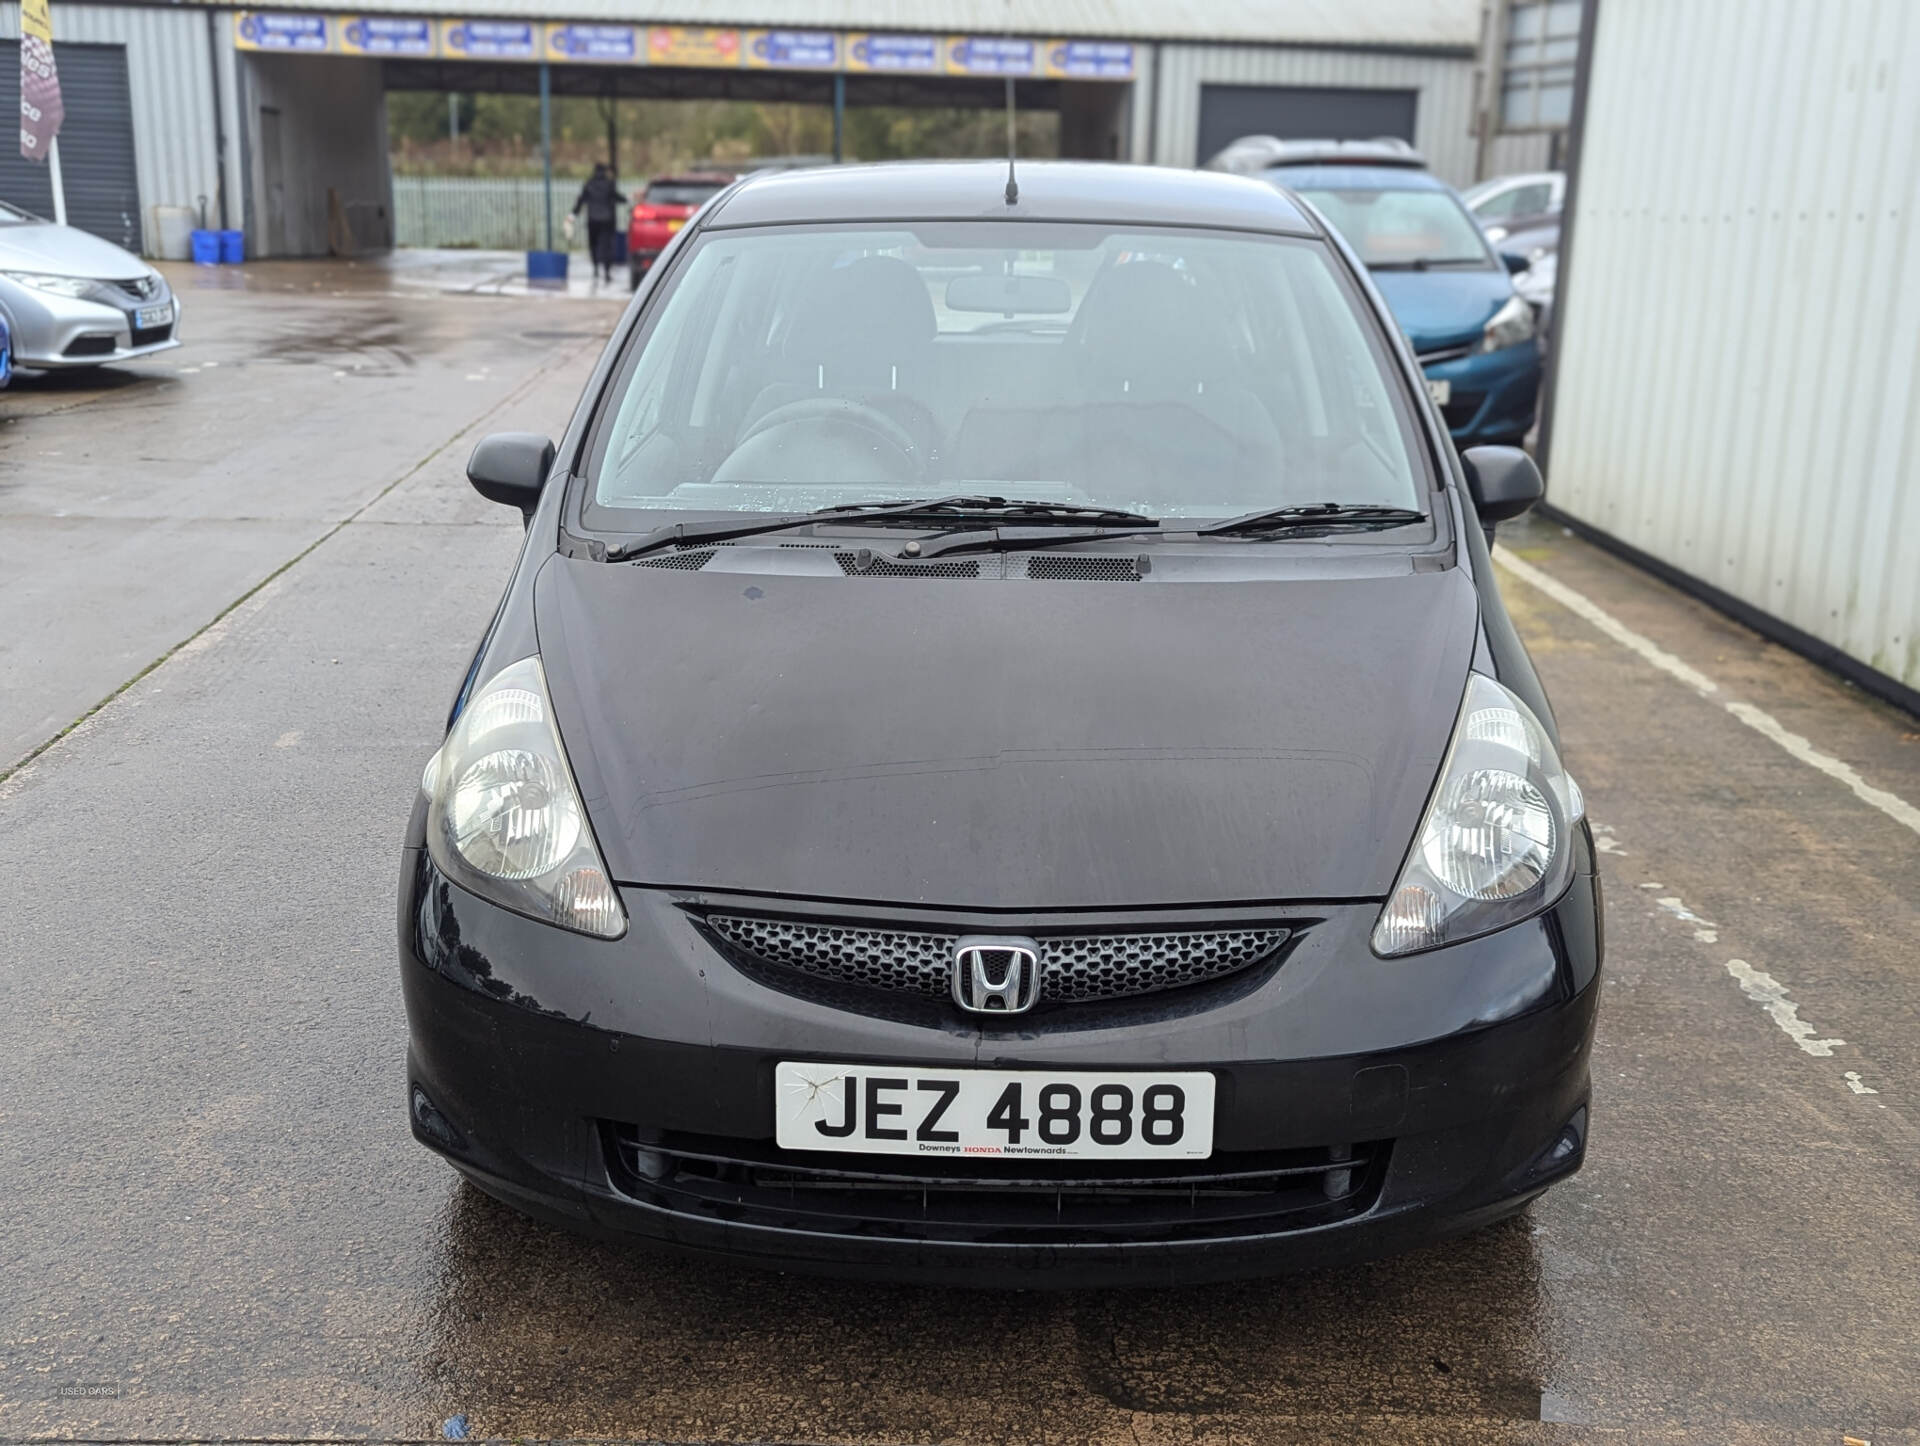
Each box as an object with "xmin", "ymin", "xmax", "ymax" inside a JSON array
[{"xmin": 601, "ymin": 1121, "xmax": 1388, "ymax": 1244}]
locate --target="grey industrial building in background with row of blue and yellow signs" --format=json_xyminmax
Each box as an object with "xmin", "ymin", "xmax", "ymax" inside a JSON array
[{"xmin": 0, "ymin": 0, "xmax": 1565, "ymax": 255}]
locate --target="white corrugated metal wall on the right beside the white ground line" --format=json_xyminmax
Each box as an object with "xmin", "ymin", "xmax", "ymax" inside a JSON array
[{"xmin": 1549, "ymin": 0, "xmax": 1920, "ymax": 687}]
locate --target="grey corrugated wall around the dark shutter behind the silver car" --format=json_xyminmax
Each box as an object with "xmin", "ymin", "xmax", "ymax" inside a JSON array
[{"xmin": 0, "ymin": 4, "xmax": 238, "ymax": 252}]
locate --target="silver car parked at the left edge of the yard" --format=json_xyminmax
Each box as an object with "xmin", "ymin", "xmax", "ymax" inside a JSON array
[{"xmin": 0, "ymin": 202, "xmax": 180, "ymax": 369}]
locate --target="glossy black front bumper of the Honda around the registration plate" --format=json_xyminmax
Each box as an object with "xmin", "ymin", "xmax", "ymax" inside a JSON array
[{"xmin": 399, "ymin": 833, "xmax": 1601, "ymax": 1287}]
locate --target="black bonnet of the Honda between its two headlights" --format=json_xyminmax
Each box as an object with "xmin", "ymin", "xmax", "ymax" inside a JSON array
[{"xmin": 534, "ymin": 557, "xmax": 1476, "ymax": 910}]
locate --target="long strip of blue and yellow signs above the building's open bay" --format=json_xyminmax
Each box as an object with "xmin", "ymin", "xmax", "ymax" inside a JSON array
[{"xmin": 234, "ymin": 10, "xmax": 1135, "ymax": 81}]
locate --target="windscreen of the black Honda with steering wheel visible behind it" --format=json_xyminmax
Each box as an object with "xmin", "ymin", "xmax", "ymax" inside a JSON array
[{"xmin": 589, "ymin": 221, "xmax": 1423, "ymax": 530}]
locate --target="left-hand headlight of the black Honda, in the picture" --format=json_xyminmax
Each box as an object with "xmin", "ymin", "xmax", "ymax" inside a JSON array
[{"xmin": 420, "ymin": 657, "xmax": 626, "ymax": 939}]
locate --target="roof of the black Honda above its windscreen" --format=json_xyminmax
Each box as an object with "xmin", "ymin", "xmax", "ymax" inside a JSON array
[{"xmin": 707, "ymin": 161, "xmax": 1321, "ymax": 236}]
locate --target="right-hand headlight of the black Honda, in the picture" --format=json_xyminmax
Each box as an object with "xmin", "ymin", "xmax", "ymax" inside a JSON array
[{"xmin": 1373, "ymin": 672, "xmax": 1586, "ymax": 958}]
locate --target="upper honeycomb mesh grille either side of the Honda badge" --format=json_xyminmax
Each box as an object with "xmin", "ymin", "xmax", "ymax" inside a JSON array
[{"xmin": 707, "ymin": 914, "xmax": 1288, "ymax": 1004}]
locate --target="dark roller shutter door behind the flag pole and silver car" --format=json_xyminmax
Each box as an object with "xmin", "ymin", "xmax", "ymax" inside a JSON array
[{"xmin": 0, "ymin": 40, "xmax": 140, "ymax": 255}]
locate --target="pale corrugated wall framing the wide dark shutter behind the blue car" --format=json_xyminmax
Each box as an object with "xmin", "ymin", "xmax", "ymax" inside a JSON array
[{"xmin": 1135, "ymin": 44, "xmax": 1475, "ymax": 186}]
